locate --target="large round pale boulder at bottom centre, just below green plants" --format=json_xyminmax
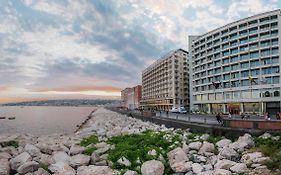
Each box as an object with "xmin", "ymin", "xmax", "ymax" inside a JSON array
[{"xmin": 141, "ymin": 160, "xmax": 165, "ymax": 175}]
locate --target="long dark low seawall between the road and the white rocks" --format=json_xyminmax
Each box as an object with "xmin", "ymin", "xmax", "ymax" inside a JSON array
[{"xmin": 108, "ymin": 108, "xmax": 281, "ymax": 138}]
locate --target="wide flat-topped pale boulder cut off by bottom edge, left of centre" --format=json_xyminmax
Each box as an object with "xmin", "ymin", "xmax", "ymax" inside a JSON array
[{"xmin": 77, "ymin": 165, "xmax": 116, "ymax": 175}]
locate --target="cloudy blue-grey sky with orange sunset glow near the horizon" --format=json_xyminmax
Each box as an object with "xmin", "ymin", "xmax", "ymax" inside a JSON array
[{"xmin": 0, "ymin": 0, "xmax": 281, "ymax": 103}]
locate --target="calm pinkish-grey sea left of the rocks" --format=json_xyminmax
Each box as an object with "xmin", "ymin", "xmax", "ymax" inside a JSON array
[{"xmin": 0, "ymin": 106, "xmax": 95, "ymax": 136}]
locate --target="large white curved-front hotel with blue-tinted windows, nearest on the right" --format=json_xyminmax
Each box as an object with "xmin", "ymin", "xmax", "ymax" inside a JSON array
[{"xmin": 189, "ymin": 10, "xmax": 281, "ymax": 114}]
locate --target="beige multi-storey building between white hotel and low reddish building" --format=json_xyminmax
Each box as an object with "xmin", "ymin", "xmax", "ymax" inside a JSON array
[{"xmin": 141, "ymin": 49, "xmax": 189, "ymax": 110}]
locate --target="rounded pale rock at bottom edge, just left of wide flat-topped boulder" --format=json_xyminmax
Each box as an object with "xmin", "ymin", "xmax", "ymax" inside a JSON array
[{"xmin": 48, "ymin": 162, "xmax": 75, "ymax": 175}]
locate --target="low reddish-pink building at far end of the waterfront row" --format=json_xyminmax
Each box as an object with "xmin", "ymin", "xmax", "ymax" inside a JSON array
[{"xmin": 121, "ymin": 85, "xmax": 142, "ymax": 110}]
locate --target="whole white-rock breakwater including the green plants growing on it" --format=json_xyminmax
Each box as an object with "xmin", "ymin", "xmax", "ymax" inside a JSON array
[{"xmin": 0, "ymin": 108, "xmax": 280, "ymax": 175}]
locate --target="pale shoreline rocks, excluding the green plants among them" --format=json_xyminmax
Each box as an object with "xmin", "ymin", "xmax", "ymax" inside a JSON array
[{"xmin": 0, "ymin": 109, "xmax": 279, "ymax": 175}]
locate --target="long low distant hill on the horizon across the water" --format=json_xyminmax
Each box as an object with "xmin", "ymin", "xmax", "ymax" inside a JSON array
[{"xmin": 2, "ymin": 99, "xmax": 120, "ymax": 106}]
